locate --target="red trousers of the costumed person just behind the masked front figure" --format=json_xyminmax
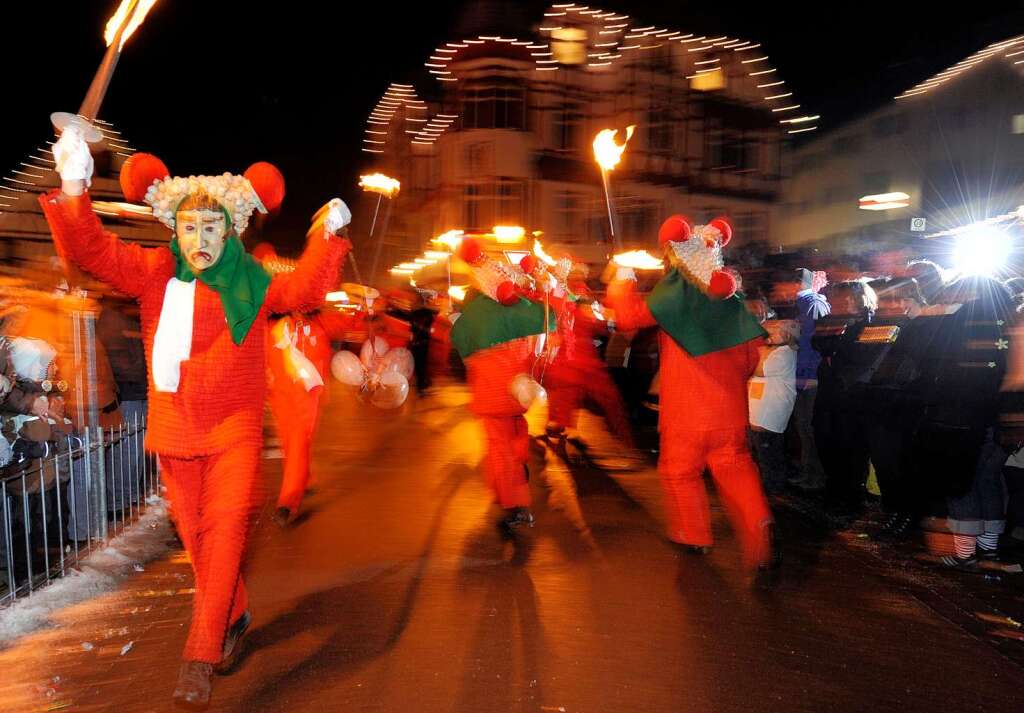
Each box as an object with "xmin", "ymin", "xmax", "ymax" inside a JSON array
[{"xmin": 269, "ymin": 384, "xmax": 324, "ymax": 513}]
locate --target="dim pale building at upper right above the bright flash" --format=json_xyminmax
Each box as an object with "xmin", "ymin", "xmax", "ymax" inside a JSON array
[{"xmin": 773, "ymin": 37, "xmax": 1024, "ymax": 253}]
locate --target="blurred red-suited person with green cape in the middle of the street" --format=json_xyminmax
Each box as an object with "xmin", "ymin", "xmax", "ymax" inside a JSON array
[{"xmin": 452, "ymin": 238, "xmax": 554, "ymax": 530}]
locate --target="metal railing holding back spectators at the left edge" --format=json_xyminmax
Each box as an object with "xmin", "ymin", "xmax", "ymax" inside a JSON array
[{"xmin": 0, "ymin": 417, "xmax": 160, "ymax": 607}]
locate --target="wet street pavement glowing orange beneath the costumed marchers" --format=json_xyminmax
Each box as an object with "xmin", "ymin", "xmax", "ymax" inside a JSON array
[{"xmin": 0, "ymin": 385, "xmax": 1024, "ymax": 713}]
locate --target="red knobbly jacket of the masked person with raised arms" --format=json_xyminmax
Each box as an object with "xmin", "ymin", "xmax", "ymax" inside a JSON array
[{"xmin": 39, "ymin": 191, "xmax": 350, "ymax": 458}]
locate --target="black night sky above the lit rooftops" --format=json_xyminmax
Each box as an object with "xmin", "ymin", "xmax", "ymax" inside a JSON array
[{"xmin": 0, "ymin": 0, "xmax": 1024, "ymax": 250}]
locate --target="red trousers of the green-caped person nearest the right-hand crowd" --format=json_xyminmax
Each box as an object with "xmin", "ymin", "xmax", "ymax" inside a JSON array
[{"xmin": 657, "ymin": 428, "xmax": 772, "ymax": 567}]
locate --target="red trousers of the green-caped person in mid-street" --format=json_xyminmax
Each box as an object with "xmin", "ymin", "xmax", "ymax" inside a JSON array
[{"xmin": 479, "ymin": 416, "xmax": 529, "ymax": 508}]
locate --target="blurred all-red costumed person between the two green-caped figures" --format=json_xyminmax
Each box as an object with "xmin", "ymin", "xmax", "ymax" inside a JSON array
[{"xmin": 520, "ymin": 255, "xmax": 633, "ymax": 448}]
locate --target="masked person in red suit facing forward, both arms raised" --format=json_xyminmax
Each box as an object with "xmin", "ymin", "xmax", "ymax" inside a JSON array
[{"xmin": 40, "ymin": 124, "xmax": 350, "ymax": 706}]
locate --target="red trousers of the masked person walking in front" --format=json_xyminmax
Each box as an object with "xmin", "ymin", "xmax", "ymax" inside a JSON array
[{"xmin": 160, "ymin": 444, "xmax": 261, "ymax": 664}]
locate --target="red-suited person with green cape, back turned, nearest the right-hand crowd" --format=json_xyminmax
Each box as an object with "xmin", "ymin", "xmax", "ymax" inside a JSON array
[{"xmin": 608, "ymin": 215, "xmax": 776, "ymax": 569}]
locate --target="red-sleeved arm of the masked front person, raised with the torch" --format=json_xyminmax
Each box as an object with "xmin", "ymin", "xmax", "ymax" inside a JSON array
[{"xmin": 39, "ymin": 191, "xmax": 173, "ymax": 297}]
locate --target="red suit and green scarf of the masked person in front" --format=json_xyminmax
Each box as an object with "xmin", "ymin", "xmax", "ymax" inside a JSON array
[{"xmin": 40, "ymin": 191, "xmax": 350, "ymax": 664}]
